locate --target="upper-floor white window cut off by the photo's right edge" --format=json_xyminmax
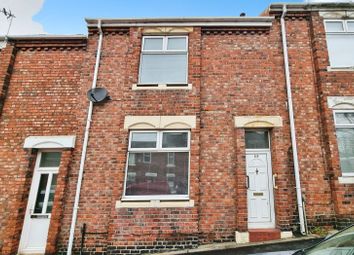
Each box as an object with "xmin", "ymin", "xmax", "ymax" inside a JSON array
[{"xmin": 325, "ymin": 20, "xmax": 354, "ymax": 67}]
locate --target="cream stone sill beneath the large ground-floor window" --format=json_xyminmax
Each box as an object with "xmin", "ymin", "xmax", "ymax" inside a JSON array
[{"xmin": 116, "ymin": 200, "xmax": 194, "ymax": 209}]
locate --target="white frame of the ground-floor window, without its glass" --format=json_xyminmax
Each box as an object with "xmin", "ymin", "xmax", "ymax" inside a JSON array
[{"xmin": 122, "ymin": 129, "xmax": 191, "ymax": 201}]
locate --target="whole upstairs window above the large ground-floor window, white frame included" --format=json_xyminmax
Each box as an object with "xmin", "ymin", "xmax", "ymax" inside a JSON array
[{"xmin": 139, "ymin": 36, "xmax": 188, "ymax": 84}]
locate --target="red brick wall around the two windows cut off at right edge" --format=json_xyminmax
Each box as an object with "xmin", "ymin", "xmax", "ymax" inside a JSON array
[{"xmin": 311, "ymin": 13, "xmax": 354, "ymax": 225}]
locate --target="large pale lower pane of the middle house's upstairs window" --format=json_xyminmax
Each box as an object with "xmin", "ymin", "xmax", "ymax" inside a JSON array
[{"xmin": 140, "ymin": 54, "xmax": 187, "ymax": 84}]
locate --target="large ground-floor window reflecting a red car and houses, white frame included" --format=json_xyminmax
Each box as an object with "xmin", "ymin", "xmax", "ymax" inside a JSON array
[{"xmin": 124, "ymin": 130, "xmax": 190, "ymax": 200}]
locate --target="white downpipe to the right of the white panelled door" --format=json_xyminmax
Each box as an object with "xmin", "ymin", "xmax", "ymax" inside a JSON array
[{"xmin": 280, "ymin": 4, "xmax": 306, "ymax": 235}]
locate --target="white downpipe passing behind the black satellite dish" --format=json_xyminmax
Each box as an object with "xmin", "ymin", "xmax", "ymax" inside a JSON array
[{"xmin": 66, "ymin": 20, "xmax": 103, "ymax": 255}]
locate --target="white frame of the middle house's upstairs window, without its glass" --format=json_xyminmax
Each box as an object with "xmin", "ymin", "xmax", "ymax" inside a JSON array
[{"xmin": 138, "ymin": 35, "xmax": 189, "ymax": 85}]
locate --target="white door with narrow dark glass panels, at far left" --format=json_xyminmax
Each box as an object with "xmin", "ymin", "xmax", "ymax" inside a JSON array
[{"xmin": 19, "ymin": 151, "xmax": 61, "ymax": 254}]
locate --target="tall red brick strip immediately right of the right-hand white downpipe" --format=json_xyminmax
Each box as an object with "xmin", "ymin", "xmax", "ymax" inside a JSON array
[{"xmin": 287, "ymin": 13, "xmax": 334, "ymax": 223}]
